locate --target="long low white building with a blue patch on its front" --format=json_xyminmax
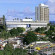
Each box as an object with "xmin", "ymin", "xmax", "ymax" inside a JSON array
[{"xmin": 6, "ymin": 21, "xmax": 47, "ymax": 30}]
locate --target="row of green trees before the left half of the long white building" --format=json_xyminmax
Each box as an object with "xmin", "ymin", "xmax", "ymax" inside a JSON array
[{"xmin": 0, "ymin": 27, "xmax": 25, "ymax": 39}]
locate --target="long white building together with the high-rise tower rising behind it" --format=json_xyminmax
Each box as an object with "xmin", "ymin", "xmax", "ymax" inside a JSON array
[{"xmin": 6, "ymin": 4, "xmax": 49, "ymax": 30}]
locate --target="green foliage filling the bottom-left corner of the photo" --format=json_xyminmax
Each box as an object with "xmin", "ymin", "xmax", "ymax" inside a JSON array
[{"xmin": 0, "ymin": 44, "xmax": 27, "ymax": 55}]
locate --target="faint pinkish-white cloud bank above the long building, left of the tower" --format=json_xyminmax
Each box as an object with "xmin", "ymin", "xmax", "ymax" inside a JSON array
[{"xmin": 6, "ymin": 7, "xmax": 35, "ymax": 19}]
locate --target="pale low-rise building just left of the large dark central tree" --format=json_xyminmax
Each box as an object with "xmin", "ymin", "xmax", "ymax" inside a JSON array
[{"xmin": 8, "ymin": 37, "xmax": 23, "ymax": 49}]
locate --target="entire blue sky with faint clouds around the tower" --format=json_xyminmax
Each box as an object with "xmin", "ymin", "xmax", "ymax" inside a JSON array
[{"xmin": 0, "ymin": 0, "xmax": 55, "ymax": 21}]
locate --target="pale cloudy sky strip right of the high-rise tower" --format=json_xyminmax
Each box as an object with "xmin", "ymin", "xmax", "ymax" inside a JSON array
[{"xmin": 46, "ymin": 0, "xmax": 55, "ymax": 21}]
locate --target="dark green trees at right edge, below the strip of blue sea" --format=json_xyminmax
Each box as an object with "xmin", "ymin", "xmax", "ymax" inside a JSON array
[{"xmin": 45, "ymin": 24, "xmax": 55, "ymax": 41}]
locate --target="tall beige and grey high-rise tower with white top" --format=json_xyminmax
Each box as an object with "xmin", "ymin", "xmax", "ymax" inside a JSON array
[{"xmin": 35, "ymin": 4, "xmax": 49, "ymax": 22}]
